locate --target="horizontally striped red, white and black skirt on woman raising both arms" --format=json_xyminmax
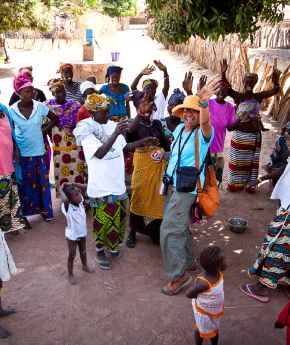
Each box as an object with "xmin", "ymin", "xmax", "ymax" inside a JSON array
[{"xmin": 228, "ymin": 131, "xmax": 262, "ymax": 192}]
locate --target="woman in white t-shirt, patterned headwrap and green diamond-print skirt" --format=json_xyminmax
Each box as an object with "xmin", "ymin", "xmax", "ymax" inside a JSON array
[{"xmin": 74, "ymin": 94, "xmax": 157, "ymax": 270}]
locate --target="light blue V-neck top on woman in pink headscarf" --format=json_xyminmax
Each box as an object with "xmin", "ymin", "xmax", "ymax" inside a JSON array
[{"xmin": 9, "ymin": 101, "xmax": 49, "ymax": 157}]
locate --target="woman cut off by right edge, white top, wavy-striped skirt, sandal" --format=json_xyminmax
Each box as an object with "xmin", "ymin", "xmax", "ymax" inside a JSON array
[{"xmin": 240, "ymin": 162, "xmax": 290, "ymax": 303}]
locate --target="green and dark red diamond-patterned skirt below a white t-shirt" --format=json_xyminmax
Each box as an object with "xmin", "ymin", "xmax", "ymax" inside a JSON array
[{"xmin": 89, "ymin": 194, "xmax": 128, "ymax": 253}]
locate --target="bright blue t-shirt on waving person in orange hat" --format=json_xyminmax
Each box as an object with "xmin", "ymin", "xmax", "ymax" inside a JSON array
[{"xmin": 166, "ymin": 124, "xmax": 214, "ymax": 194}]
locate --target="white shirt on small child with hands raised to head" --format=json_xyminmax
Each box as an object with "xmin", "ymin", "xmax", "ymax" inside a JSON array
[{"xmin": 61, "ymin": 198, "xmax": 87, "ymax": 241}]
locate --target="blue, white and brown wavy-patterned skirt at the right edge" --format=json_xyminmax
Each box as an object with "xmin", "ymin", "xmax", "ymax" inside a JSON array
[{"xmin": 249, "ymin": 207, "xmax": 290, "ymax": 289}]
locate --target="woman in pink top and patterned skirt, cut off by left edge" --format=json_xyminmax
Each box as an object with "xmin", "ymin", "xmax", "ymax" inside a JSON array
[{"xmin": 0, "ymin": 104, "xmax": 24, "ymax": 233}]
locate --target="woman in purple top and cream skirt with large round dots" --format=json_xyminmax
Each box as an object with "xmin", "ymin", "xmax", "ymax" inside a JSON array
[{"xmin": 46, "ymin": 79, "xmax": 85, "ymax": 198}]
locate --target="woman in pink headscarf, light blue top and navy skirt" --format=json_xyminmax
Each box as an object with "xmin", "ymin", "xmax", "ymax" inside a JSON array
[{"xmin": 9, "ymin": 74, "xmax": 58, "ymax": 227}]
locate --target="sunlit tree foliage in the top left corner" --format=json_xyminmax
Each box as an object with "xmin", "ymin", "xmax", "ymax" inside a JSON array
[{"xmin": 0, "ymin": 0, "xmax": 52, "ymax": 32}]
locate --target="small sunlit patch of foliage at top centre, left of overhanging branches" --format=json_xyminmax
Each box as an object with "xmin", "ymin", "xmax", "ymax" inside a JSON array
[{"xmin": 101, "ymin": 0, "xmax": 137, "ymax": 17}]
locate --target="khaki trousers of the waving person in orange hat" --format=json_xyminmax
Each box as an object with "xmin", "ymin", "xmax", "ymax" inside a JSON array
[{"xmin": 160, "ymin": 187, "xmax": 196, "ymax": 281}]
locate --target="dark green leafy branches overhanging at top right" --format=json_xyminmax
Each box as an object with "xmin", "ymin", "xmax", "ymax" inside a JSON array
[{"xmin": 147, "ymin": 0, "xmax": 288, "ymax": 44}]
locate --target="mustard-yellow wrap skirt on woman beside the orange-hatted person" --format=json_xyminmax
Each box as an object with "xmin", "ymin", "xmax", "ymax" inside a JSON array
[{"xmin": 130, "ymin": 147, "xmax": 166, "ymax": 219}]
